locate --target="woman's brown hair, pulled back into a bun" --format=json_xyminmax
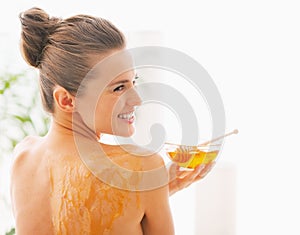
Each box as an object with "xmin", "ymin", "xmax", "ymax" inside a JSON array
[{"xmin": 19, "ymin": 7, "xmax": 125, "ymax": 113}]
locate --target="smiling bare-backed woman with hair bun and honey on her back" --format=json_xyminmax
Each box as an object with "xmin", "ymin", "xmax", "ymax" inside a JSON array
[{"xmin": 11, "ymin": 8, "xmax": 210, "ymax": 235}]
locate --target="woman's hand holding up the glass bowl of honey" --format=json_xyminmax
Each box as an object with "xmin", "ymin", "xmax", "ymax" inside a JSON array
[{"xmin": 169, "ymin": 162, "xmax": 215, "ymax": 196}]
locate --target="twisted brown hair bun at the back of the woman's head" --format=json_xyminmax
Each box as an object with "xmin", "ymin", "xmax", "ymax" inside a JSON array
[{"xmin": 19, "ymin": 7, "xmax": 59, "ymax": 67}]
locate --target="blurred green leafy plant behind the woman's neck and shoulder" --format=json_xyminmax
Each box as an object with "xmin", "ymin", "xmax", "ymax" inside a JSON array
[{"xmin": 0, "ymin": 71, "xmax": 50, "ymax": 235}]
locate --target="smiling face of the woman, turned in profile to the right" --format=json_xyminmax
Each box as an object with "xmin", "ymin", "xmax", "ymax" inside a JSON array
[{"xmin": 76, "ymin": 50, "xmax": 141, "ymax": 137}]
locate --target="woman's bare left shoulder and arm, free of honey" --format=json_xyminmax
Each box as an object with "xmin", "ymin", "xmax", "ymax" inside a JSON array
[{"xmin": 10, "ymin": 136, "xmax": 52, "ymax": 234}]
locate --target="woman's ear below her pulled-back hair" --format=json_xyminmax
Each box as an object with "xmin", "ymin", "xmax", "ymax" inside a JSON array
[{"xmin": 53, "ymin": 86, "xmax": 75, "ymax": 113}]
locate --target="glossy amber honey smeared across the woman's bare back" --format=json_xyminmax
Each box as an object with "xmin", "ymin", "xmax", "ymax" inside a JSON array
[{"xmin": 49, "ymin": 154, "xmax": 140, "ymax": 235}]
